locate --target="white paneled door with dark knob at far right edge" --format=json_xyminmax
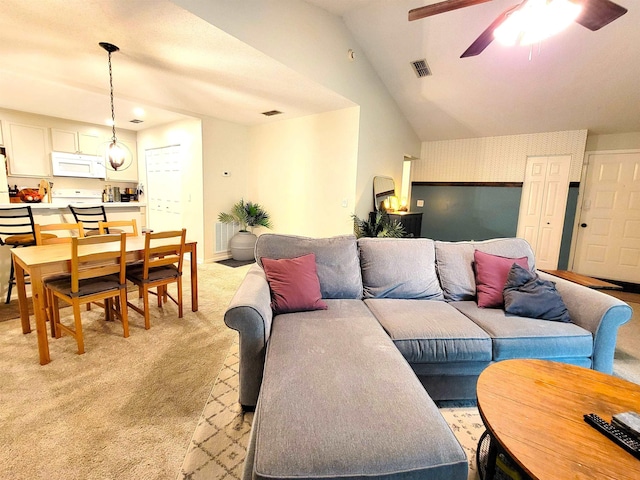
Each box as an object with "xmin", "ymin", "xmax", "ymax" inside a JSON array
[{"xmin": 573, "ymin": 151, "xmax": 640, "ymax": 283}]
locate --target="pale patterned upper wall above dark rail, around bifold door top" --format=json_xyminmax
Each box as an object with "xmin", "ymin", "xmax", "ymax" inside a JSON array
[{"xmin": 418, "ymin": 130, "xmax": 587, "ymax": 182}]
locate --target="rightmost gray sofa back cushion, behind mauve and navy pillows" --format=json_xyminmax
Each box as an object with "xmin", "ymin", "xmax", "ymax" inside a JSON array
[{"xmin": 435, "ymin": 238, "xmax": 535, "ymax": 302}]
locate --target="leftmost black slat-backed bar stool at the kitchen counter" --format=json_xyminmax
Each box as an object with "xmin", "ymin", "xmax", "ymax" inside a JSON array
[{"xmin": 0, "ymin": 205, "xmax": 56, "ymax": 303}]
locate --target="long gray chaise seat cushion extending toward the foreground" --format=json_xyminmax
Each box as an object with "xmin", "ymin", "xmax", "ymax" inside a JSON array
[{"xmin": 252, "ymin": 300, "xmax": 468, "ymax": 480}]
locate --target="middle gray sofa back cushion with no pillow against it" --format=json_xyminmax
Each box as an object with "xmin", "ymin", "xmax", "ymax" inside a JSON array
[{"xmin": 358, "ymin": 238, "xmax": 444, "ymax": 300}]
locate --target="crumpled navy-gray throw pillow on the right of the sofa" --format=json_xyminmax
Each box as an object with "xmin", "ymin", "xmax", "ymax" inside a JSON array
[{"xmin": 502, "ymin": 263, "xmax": 571, "ymax": 322}]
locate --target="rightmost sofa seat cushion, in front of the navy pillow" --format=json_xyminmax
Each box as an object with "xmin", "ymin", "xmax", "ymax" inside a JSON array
[{"xmin": 450, "ymin": 301, "xmax": 593, "ymax": 366}]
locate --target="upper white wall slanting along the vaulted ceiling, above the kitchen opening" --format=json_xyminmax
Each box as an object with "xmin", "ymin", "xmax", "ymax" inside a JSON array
[{"xmin": 173, "ymin": 0, "xmax": 420, "ymax": 216}]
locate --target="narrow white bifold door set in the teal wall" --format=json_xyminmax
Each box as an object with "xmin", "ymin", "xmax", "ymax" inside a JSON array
[{"xmin": 517, "ymin": 155, "xmax": 571, "ymax": 270}]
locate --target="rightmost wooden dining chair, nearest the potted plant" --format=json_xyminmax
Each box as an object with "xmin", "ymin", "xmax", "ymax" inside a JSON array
[{"xmin": 127, "ymin": 228, "xmax": 187, "ymax": 330}]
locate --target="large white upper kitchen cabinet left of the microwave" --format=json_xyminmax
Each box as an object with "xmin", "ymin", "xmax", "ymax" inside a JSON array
[{"xmin": 5, "ymin": 122, "xmax": 51, "ymax": 177}]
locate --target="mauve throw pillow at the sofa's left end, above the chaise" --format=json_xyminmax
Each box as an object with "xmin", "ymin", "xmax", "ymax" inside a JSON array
[{"xmin": 261, "ymin": 253, "xmax": 327, "ymax": 314}]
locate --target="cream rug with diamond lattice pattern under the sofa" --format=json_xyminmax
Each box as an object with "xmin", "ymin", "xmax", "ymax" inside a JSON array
[{"xmin": 178, "ymin": 341, "xmax": 485, "ymax": 480}]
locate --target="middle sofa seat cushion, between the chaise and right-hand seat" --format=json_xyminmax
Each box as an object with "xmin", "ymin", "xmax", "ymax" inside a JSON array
[{"xmin": 365, "ymin": 298, "xmax": 491, "ymax": 364}]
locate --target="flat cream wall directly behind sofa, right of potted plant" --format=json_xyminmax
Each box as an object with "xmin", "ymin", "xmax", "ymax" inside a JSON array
[{"xmin": 246, "ymin": 107, "xmax": 359, "ymax": 237}]
